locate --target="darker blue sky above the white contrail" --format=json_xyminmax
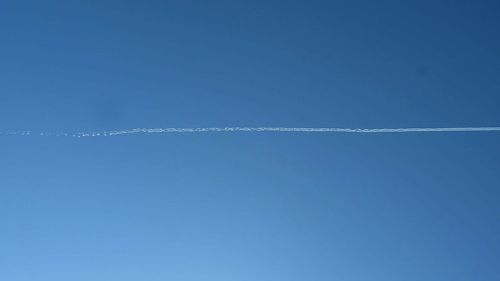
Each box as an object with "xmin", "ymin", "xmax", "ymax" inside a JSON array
[{"xmin": 0, "ymin": 1, "xmax": 500, "ymax": 130}]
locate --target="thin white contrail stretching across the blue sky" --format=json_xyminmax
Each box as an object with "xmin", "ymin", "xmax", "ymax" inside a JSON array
[{"xmin": 0, "ymin": 127, "xmax": 500, "ymax": 138}]
